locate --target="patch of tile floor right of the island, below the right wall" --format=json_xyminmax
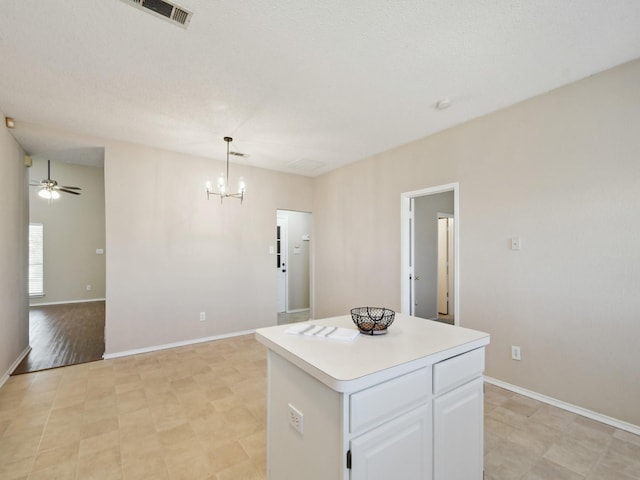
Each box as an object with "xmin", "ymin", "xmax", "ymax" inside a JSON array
[{"xmin": 484, "ymin": 384, "xmax": 640, "ymax": 480}]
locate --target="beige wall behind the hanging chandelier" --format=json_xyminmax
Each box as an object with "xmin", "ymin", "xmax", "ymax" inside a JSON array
[{"xmin": 105, "ymin": 139, "xmax": 312, "ymax": 354}]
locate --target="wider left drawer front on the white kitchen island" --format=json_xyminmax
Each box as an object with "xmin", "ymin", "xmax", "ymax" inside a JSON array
[{"xmin": 349, "ymin": 368, "xmax": 431, "ymax": 432}]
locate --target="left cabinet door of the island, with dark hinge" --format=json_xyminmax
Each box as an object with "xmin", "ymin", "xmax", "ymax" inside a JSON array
[{"xmin": 351, "ymin": 404, "xmax": 432, "ymax": 480}]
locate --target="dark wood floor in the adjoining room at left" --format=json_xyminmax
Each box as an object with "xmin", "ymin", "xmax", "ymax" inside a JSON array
[{"xmin": 12, "ymin": 301, "xmax": 104, "ymax": 375}]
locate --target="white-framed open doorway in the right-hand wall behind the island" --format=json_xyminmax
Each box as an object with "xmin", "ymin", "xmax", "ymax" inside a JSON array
[{"xmin": 401, "ymin": 183, "xmax": 460, "ymax": 325}]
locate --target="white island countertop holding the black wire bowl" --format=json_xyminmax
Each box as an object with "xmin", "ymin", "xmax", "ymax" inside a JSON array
[{"xmin": 256, "ymin": 313, "xmax": 489, "ymax": 392}]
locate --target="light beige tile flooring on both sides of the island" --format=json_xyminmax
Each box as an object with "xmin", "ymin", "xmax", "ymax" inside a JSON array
[{"xmin": 0, "ymin": 336, "xmax": 640, "ymax": 480}]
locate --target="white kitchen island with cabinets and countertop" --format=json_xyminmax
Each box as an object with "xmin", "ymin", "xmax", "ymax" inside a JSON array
[{"xmin": 256, "ymin": 314, "xmax": 489, "ymax": 480}]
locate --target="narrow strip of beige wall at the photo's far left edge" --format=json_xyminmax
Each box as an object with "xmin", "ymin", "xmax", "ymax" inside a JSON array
[{"xmin": 0, "ymin": 112, "xmax": 29, "ymax": 385}]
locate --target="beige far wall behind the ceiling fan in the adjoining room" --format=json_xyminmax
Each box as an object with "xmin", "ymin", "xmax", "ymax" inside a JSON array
[{"xmin": 29, "ymin": 159, "xmax": 108, "ymax": 305}]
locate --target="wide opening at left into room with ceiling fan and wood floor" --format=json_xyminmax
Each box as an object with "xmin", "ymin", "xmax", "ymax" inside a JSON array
[{"xmin": 19, "ymin": 156, "xmax": 106, "ymax": 373}]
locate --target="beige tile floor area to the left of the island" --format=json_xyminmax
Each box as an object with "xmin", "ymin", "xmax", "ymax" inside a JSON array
[{"xmin": 0, "ymin": 336, "xmax": 266, "ymax": 480}]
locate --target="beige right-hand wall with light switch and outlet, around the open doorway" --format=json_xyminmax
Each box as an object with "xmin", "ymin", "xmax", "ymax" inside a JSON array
[{"xmin": 313, "ymin": 61, "xmax": 640, "ymax": 425}]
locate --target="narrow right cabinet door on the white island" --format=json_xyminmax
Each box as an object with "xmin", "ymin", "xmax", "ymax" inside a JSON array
[{"xmin": 433, "ymin": 377, "xmax": 483, "ymax": 480}]
